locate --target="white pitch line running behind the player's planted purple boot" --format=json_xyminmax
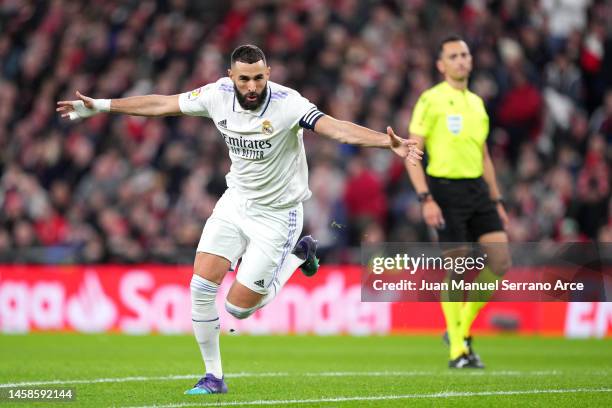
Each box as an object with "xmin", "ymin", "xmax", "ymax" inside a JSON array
[{"xmin": 0, "ymin": 371, "xmax": 561, "ymax": 388}]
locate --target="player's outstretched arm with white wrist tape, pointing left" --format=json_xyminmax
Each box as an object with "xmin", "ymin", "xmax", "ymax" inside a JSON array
[{"xmin": 56, "ymin": 91, "xmax": 182, "ymax": 120}]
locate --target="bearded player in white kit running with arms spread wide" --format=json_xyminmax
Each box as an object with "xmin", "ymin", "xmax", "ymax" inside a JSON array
[{"xmin": 57, "ymin": 45, "xmax": 422, "ymax": 394}]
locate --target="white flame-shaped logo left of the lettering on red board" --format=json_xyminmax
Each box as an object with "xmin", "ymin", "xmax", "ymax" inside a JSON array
[{"xmin": 66, "ymin": 271, "xmax": 117, "ymax": 332}]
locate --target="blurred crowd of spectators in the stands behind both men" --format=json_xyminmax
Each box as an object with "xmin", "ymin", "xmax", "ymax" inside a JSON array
[{"xmin": 0, "ymin": 0, "xmax": 612, "ymax": 263}]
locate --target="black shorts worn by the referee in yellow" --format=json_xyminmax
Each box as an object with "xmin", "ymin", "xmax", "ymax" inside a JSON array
[{"xmin": 429, "ymin": 177, "xmax": 504, "ymax": 242}]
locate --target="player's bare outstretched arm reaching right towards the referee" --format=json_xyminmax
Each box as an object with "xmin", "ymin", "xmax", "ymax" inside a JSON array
[{"xmin": 314, "ymin": 115, "xmax": 423, "ymax": 164}]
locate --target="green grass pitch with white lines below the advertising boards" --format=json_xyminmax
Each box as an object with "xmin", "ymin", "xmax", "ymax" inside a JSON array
[{"xmin": 0, "ymin": 334, "xmax": 612, "ymax": 408}]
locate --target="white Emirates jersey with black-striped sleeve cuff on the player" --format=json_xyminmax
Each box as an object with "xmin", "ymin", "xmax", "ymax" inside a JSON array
[{"xmin": 179, "ymin": 77, "xmax": 323, "ymax": 208}]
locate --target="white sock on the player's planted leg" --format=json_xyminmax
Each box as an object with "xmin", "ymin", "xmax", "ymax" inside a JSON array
[{"xmin": 190, "ymin": 274, "xmax": 223, "ymax": 378}]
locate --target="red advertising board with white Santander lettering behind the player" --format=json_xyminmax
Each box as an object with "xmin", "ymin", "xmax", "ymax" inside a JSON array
[{"xmin": 0, "ymin": 265, "xmax": 612, "ymax": 337}]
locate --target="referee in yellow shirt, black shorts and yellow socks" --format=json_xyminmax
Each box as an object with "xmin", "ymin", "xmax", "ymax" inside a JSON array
[{"xmin": 406, "ymin": 36, "xmax": 510, "ymax": 368}]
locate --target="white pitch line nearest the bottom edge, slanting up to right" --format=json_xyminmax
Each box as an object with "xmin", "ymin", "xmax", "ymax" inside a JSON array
[{"xmin": 119, "ymin": 388, "xmax": 612, "ymax": 408}]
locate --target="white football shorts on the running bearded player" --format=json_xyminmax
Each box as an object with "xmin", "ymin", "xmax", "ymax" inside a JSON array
[{"xmin": 197, "ymin": 188, "xmax": 304, "ymax": 295}]
